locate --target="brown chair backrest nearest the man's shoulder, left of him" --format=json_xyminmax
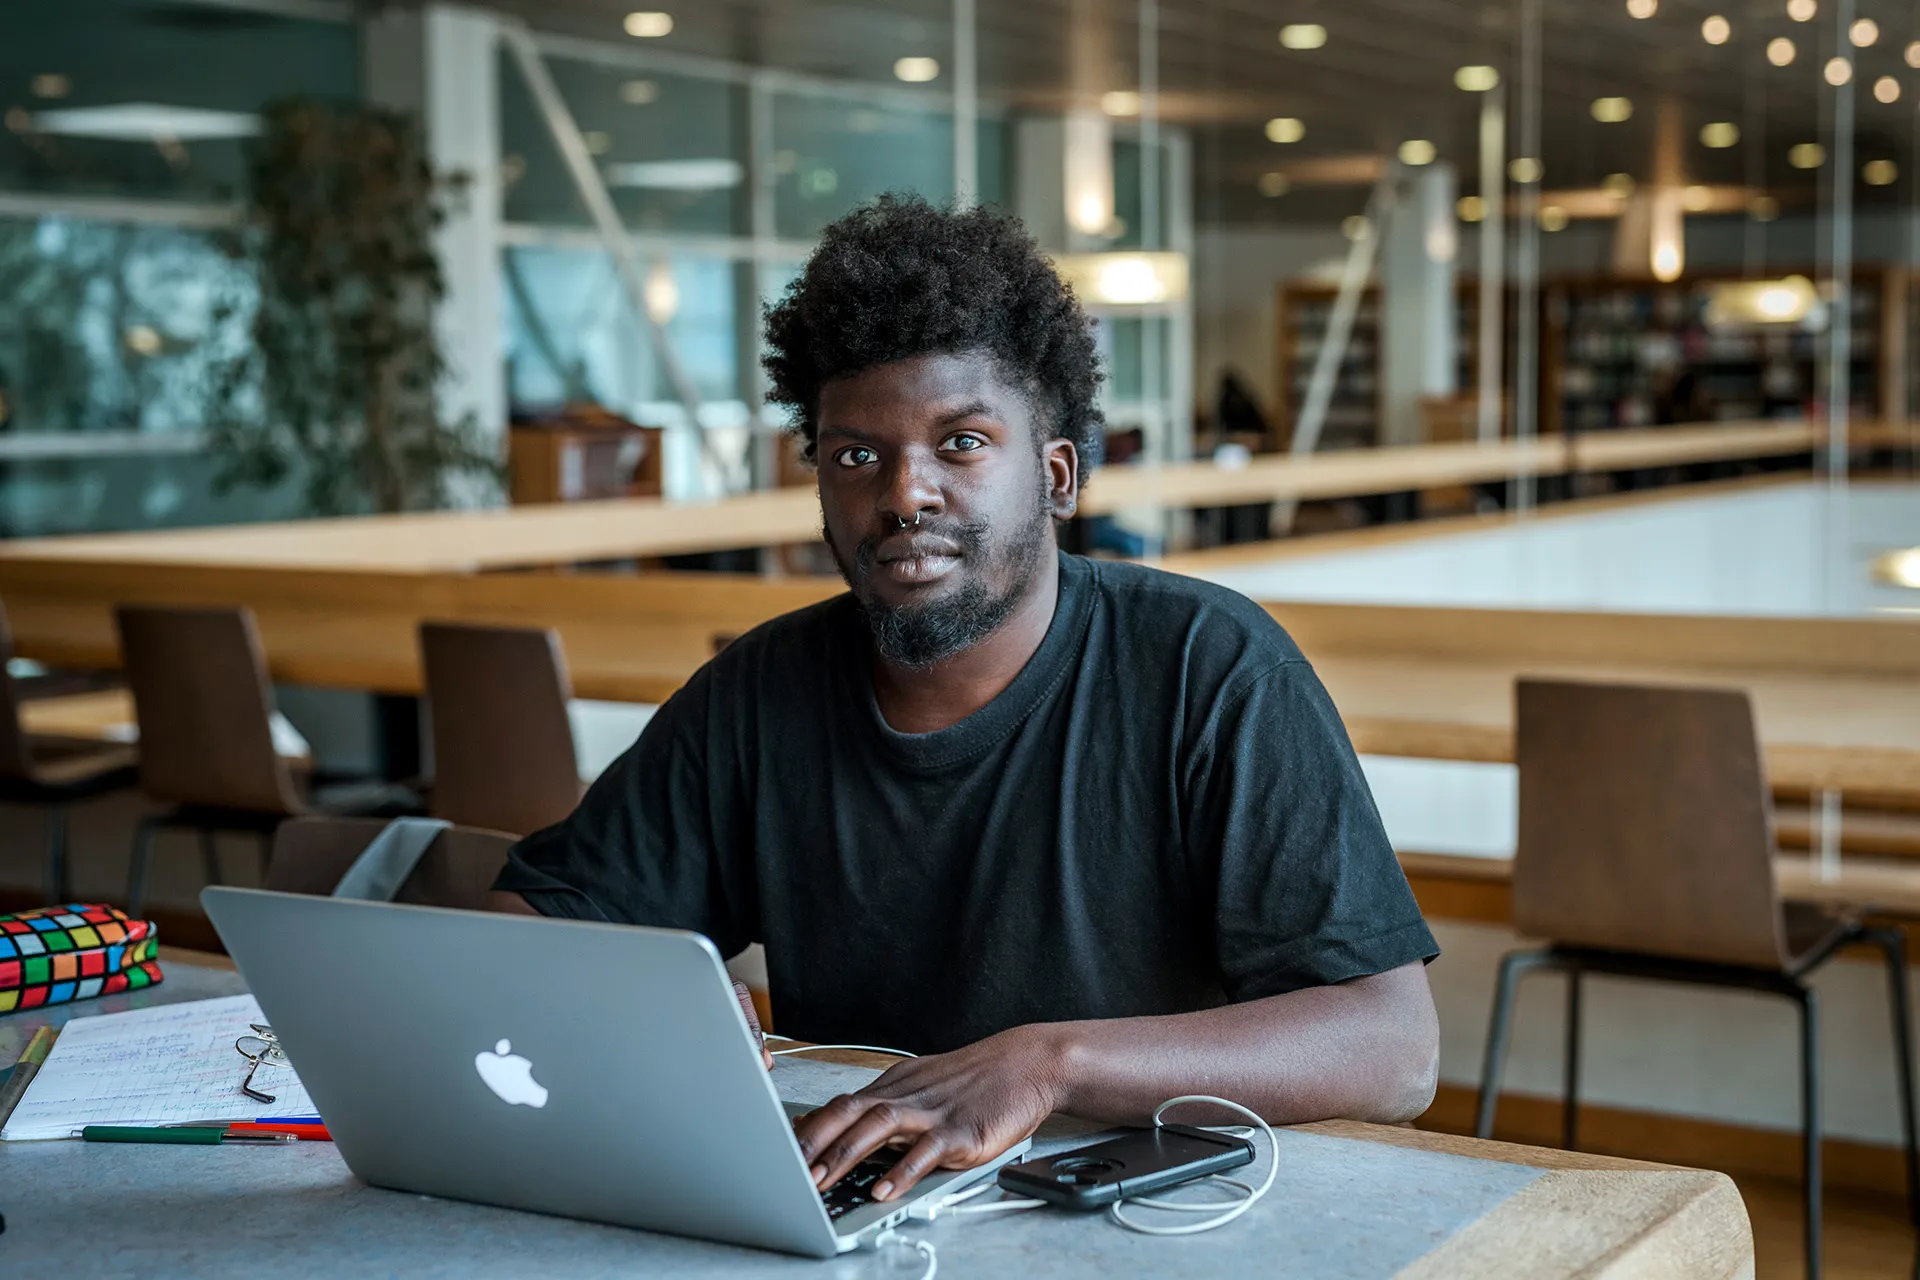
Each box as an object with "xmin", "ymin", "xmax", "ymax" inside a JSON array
[{"xmin": 420, "ymin": 622, "xmax": 580, "ymax": 835}]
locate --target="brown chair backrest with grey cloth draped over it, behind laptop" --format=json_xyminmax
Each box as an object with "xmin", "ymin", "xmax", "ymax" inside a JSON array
[{"xmin": 265, "ymin": 818, "xmax": 513, "ymax": 912}]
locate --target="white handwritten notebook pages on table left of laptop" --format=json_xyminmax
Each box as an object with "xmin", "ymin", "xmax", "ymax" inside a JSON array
[{"xmin": 0, "ymin": 996, "xmax": 313, "ymax": 1142}]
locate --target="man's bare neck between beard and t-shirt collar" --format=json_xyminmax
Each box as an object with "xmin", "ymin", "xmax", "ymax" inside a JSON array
[{"xmin": 874, "ymin": 553, "xmax": 1060, "ymax": 733}]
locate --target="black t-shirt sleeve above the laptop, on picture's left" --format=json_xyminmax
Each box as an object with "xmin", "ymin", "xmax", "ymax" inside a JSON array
[{"xmin": 493, "ymin": 679, "xmax": 758, "ymax": 956}]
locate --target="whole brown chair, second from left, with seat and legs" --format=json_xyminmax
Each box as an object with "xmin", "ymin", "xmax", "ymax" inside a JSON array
[{"xmin": 115, "ymin": 604, "xmax": 419, "ymax": 913}]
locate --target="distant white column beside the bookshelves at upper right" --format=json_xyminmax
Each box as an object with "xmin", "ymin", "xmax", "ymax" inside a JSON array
[{"xmin": 1380, "ymin": 165, "xmax": 1457, "ymax": 445}]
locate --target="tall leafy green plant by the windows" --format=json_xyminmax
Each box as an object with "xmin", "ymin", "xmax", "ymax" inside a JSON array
[{"xmin": 207, "ymin": 100, "xmax": 501, "ymax": 514}]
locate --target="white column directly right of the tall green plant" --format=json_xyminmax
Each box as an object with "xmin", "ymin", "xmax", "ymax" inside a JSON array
[{"xmin": 361, "ymin": 4, "xmax": 507, "ymax": 470}]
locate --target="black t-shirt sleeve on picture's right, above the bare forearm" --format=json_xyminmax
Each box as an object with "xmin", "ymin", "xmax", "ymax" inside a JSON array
[{"xmin": 1188, "ymin": 660, "xmax": 1440, "ymax": 1000}]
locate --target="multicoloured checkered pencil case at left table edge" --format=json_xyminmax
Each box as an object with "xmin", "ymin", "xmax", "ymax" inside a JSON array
[{"xmin": 0, "ymin": 902, "xmax": 159, "ymax": 1013}]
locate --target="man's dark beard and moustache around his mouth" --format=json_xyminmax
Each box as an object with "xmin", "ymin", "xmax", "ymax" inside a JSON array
[{"xmin": 828, "ymin": 493, "xmax": 1052, "ymax": 670}]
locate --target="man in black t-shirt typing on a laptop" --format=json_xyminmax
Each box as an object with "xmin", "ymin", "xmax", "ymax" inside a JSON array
[{"xmin": 495, "ymin": 198, "xmax": 1438, "ymax": 1199}]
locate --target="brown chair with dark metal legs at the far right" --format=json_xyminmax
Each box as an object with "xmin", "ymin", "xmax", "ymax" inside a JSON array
[{"xmin": 1475, "ymin": 679, "xmax": 1920, "ymax": 1278}]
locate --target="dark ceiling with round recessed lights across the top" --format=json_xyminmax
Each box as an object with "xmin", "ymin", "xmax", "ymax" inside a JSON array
[{"xmin": 509, "ymin": 0, "xmax": 1920, "ymax": 223}]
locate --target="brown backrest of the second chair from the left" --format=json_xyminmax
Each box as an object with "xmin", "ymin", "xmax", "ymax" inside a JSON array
[{"xmin": 113, "ymin": 604, "xmax": 303, "ymax": 814}]
